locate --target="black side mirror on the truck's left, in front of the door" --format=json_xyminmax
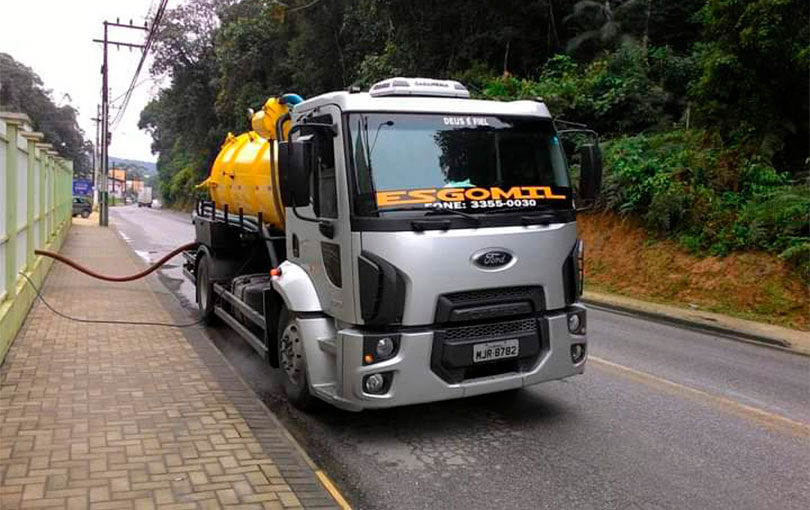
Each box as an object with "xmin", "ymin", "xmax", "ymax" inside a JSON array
[{"xmin": 278, "ymin": 136, "xmax": 312, "ymax": 207}]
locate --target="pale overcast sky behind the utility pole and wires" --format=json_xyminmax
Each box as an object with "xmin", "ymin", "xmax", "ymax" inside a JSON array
[{"xmin": 0, "ymin": 0, "xmax": 166, "ymax": 161}]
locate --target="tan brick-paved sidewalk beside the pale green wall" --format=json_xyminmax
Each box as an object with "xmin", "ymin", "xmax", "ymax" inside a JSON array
[{"xmin": 0, "ymin": 220, "xmax": 339, "ymax": 510}]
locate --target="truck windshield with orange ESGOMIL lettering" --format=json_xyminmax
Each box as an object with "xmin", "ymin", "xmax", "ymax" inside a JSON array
[{"xmin": 348, "ymin": 113, "xmax": 572, "ymax": 215}]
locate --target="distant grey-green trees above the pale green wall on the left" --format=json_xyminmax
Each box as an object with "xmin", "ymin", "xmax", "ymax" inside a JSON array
[{"xmin": 0, "ymin": 53, "xmax": 93, "ymax": 178}]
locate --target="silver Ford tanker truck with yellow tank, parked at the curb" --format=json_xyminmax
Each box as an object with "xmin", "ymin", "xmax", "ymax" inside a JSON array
[{"xmin": 183, "ymin": 78, "xmax": 602, "ymax": 411}]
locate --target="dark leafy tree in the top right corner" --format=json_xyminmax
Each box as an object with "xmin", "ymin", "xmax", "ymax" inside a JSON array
[{"xmin": 692, "ymin": 0, "xmax": 810, "ymax": 172}]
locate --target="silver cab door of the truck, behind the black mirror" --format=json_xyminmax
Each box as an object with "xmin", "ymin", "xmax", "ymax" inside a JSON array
[{"xmin": 287, "ymin": 106, "xmax": 355, "ymax": 322}]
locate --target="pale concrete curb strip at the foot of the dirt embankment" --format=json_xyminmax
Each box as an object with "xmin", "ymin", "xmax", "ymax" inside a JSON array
[{"xmin": 583, "ymin": 291, "xmax": 810, "ymax": 356}]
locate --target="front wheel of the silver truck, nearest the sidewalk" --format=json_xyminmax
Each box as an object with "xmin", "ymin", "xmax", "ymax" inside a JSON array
[{"xmin": 276, "ymin": 306, "xmax": 315, "ymax": 411}]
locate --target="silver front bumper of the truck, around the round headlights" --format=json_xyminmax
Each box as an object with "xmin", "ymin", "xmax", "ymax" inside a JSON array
[{"xmin": 312, "ymin": 305, "xmax": 587, "ymax": 410}]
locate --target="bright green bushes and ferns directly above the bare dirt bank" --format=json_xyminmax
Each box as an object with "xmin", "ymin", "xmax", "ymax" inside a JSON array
[{"xmin": 603, "ymin": 131, "xmax": 810, "ymax": 274}]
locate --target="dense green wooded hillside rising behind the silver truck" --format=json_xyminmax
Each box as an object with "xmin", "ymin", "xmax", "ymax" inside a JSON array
[{"xmin": 141, "ymin": 0, "xmax": 810, "ymax": 276}]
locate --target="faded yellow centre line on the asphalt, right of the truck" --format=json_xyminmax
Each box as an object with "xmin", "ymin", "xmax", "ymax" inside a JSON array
[{"xmin": 588, "ymin": 356, "xmax": 810, "ymax": 436}]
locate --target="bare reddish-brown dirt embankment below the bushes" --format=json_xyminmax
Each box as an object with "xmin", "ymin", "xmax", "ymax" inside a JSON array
[{"xmin": 577, "ymin": 213, "xmax": 810, "ymax": 330}]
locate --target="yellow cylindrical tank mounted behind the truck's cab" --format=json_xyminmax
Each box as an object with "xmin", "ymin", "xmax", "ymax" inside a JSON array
[{"xmin": 199, "ymin": 94, "xmax": 301, "ymax": 230}]
